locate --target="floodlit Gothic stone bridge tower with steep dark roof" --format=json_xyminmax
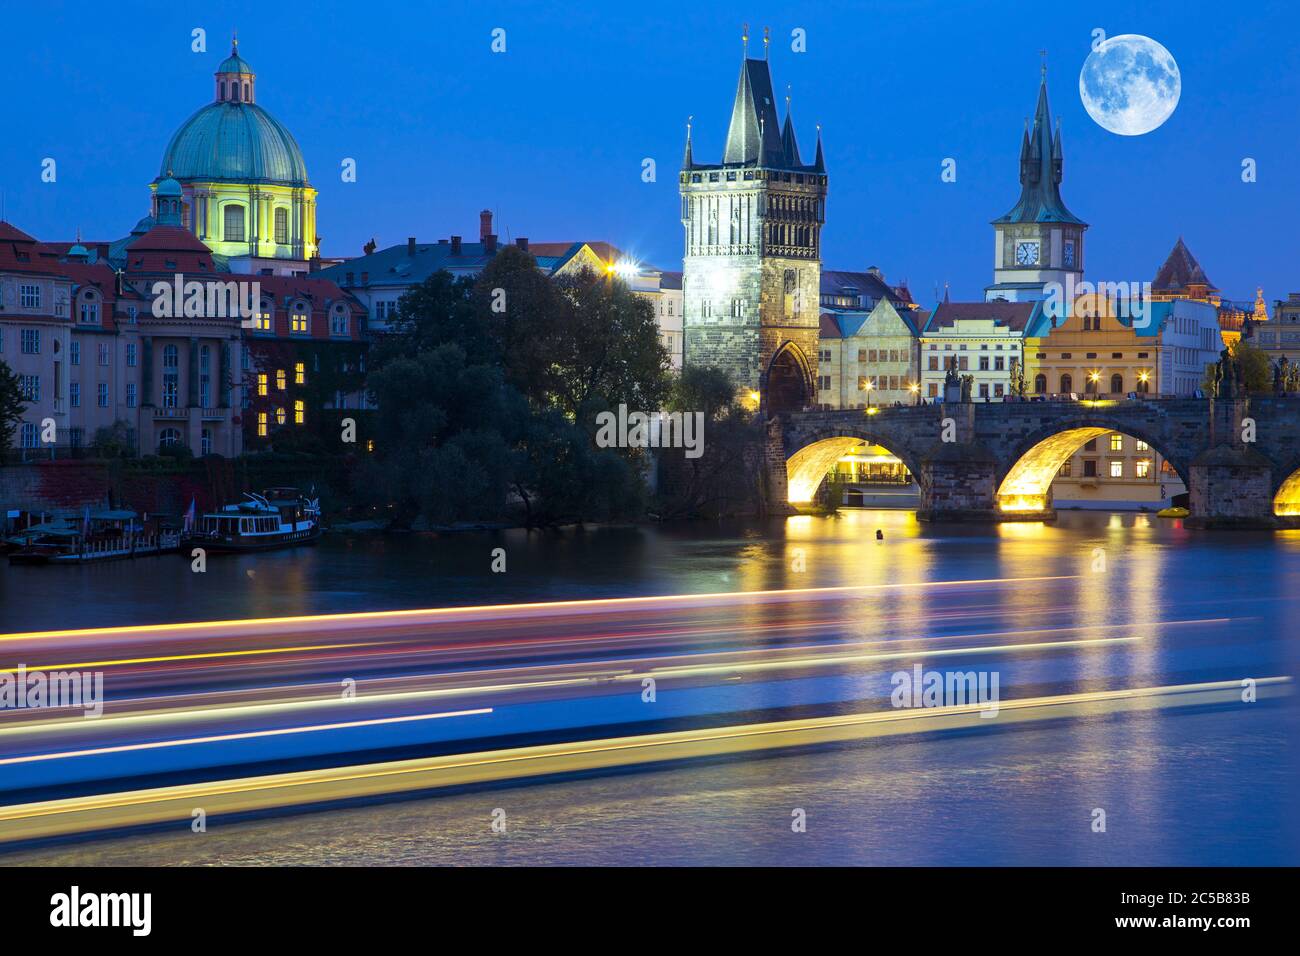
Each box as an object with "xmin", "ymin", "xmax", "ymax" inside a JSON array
[{"xmin": 679, "ymin": 27, "xmax": 827, "ymax": 415}]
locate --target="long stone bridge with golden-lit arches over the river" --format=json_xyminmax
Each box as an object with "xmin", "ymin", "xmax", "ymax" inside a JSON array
[{"xmin": 764, "ymin": 395, "xmax": 1300, "ymax": 528}]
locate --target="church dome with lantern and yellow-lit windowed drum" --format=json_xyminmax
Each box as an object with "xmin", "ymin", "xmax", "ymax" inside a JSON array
[{"xmin": 150, "ymin": 40, "xmax": 319, "ymax": 276}]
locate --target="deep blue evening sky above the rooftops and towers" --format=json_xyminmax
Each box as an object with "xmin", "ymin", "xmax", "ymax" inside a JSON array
[{"xmin": 0, "ymin": 0, "xmax": 1300, "ymax": 304}]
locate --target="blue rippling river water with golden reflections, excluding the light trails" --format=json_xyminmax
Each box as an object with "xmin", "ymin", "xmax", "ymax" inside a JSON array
[{"xmin": 0, "ymin": 511, "xmax": 1300, "ymax": 865}]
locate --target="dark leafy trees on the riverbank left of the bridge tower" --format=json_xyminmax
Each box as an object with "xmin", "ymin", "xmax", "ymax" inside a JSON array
[{"xmin": 358, "ymin": 247, "xmax": 753, "ymax": 527}]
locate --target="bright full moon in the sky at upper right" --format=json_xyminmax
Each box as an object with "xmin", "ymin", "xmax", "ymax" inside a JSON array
[{"xmin": 1079, "ymin": 34, "xmax": 1183, "ymax": 137}]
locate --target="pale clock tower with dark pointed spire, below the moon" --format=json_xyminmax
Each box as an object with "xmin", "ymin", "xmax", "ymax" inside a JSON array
[{"xmin": 984, "ymin": 65, "xmax": 1088, "ymax": 302}]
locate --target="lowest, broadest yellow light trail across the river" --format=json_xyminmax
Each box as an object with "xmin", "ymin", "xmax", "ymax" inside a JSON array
[{"xmin": 0, "ymin": 676, "xmax": 1291, "ymax": 842}]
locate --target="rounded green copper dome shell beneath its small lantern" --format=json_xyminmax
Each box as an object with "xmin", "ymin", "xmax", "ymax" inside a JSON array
[{"xmin": 159, "ymin": 100, "xmax": 309, "ymax": 186}]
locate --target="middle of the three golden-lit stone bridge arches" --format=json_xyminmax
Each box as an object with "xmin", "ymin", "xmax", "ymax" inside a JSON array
[{"xmin": 997, "ymin": 418, "xmax": 1191, "ymax": 511}]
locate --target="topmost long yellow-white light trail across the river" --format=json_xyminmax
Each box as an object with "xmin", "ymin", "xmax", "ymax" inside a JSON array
[{"xmin": 0, "ymin": 575, "xmax": 1080, "ymax": 641}]
